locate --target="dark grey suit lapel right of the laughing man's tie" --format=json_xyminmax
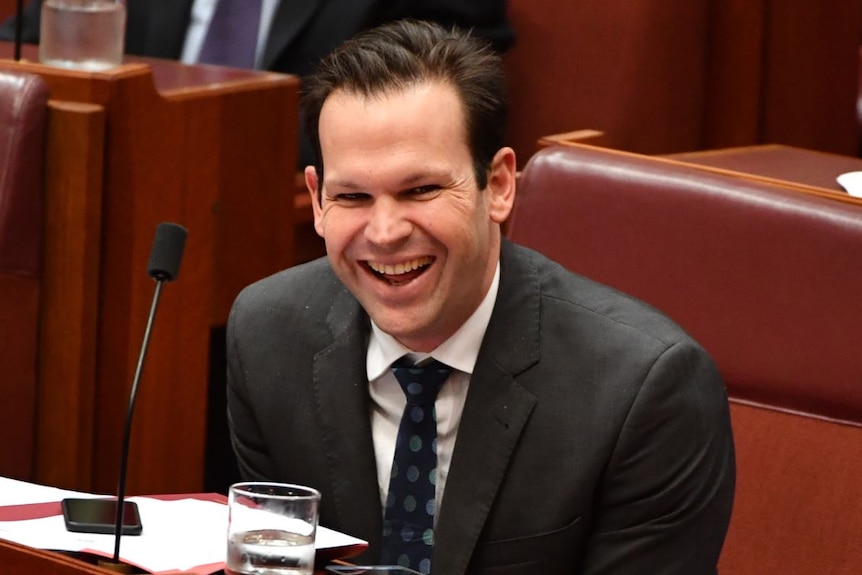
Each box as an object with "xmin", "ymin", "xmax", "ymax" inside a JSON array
[{"xmin": 432, "ymin": 243, "xmax": 540, "ymax": 575}]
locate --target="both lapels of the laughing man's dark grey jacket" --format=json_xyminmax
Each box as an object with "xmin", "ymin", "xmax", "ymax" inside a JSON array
[{"xmin": 314, "ymin": 242, "xmax": 540, "ymax": 575}]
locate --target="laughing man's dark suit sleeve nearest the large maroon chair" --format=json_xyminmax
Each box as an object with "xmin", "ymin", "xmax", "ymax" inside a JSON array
[{"xmin": 584, "ymin": 342, "xmax": 736, "ymax": 575}]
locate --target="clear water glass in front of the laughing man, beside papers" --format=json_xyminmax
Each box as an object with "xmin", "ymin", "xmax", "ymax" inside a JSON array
[{"xmin": 225, "ymin": 482, "xmax": 320, "ymax": 575}]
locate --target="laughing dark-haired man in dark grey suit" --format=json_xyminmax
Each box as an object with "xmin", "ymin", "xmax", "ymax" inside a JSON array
[{"xmin": 228, "ymin": 22, "xmax": 735, "ymax": 575}]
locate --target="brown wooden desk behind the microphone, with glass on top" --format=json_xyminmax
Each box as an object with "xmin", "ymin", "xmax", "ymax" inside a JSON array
[{"xmin": 0, "ymin": 43, "xmax": 299, "ymax": 494}]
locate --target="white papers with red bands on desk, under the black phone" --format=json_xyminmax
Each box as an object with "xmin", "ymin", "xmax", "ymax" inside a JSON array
[{"xmin": 0, "ymin": 477, "xmax": 367, "ymax": 575}]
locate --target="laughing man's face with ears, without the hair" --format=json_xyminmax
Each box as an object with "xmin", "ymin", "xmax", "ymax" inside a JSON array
[{"xmin": 306, "ymin": 82, "xmax": 515, "ymax": 352}]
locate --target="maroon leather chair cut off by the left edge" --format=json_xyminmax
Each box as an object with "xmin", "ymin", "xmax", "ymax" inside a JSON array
[{"xmin": 0, "ymin": 67, "xmax": 48, "ymax": 479}]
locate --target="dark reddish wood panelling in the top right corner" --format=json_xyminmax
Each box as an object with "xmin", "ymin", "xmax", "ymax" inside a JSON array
[{"xmin": 703, "ymin": 0, "xmax": 862, "ymax": 155}]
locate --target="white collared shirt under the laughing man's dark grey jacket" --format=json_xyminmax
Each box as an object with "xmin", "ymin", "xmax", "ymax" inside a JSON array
[{"xmin": 366, "ymin": 262, "xmax": 500, "ymax": 509}]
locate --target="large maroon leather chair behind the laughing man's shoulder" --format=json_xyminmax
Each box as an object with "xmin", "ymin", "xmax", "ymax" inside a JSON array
[{"xmin": 508, "ymin": 145, "xmax": 862, "ymax": 574}]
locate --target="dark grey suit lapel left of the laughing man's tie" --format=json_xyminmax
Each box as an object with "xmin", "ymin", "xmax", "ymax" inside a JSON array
[{"xmin": 314, "ymin": 289, "xmax": 383, "ymax": 552}]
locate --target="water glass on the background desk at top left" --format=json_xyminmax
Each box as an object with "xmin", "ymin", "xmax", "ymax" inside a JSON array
[{"xmin": 39, "ymin": 0, "xmax": 126, "ymax": 71}]
